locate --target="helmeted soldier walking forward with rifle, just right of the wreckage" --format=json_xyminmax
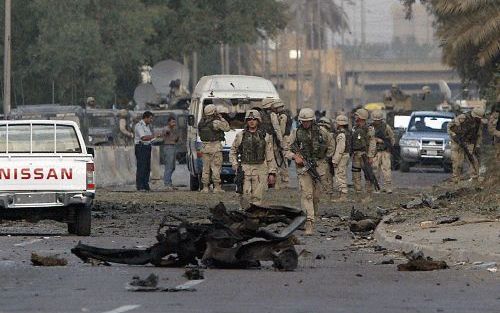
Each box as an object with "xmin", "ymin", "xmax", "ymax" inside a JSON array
[{"xmin": 285, "ymin": 108, "xmax": 334, "ymax": 235}]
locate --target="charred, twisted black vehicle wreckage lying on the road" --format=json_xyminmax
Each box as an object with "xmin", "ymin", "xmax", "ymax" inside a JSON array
[{"xmin": 71, "ymin": 202, "xmax": 306, "ymax": 271}]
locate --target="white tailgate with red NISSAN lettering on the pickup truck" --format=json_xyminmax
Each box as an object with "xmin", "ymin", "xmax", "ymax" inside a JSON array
[{"xmin": 0, "ymin": 156, "xmax": 92, "ymax": 191}]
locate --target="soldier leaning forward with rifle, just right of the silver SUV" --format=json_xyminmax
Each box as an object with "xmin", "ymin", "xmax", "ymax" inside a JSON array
[{"xmin": 448, "ymin": 108, "xmax": 484, "ymax": 184}]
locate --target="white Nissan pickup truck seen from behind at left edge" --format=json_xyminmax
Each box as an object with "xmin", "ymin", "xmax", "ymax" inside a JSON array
[{"xmin": 0, "ymin": 120, "xmax": 95, "ymax": 236}]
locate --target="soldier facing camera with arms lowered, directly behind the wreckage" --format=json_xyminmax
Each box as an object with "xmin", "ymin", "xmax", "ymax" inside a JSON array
[{"xmin": 229, "ymin": 110, "xmax": 276, "ymax": 207}]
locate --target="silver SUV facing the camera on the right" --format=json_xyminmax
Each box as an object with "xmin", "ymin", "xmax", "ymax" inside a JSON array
[{"xmin": 399, "ymin": 111, "xmax": 455, "ymax": 173}]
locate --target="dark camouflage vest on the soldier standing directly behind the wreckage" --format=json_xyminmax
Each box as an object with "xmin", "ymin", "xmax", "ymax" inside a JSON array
[{"xmin": 239, "ymin": 129, "xmax": 266, "ymax": 164}]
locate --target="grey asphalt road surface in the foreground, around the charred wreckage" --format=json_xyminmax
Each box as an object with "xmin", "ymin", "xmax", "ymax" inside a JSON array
[{"xmin": 0, "ymin": 165, "xmax": 500, "ymax": 313}]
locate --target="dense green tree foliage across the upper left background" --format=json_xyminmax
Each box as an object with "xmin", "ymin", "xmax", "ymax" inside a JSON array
[{"xmin": 0, "ymin": 0, "xmax": 287, "ymax": 107}]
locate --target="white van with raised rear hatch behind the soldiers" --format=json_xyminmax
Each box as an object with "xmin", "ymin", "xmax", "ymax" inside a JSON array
[{"xmin": 187, "ymin": 75, "xmax": 279, "ymax": 190}]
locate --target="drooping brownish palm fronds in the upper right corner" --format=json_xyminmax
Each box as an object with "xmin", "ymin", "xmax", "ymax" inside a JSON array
[{"xmin": 401, "ymin": 0, "xmax": 500, "ymax": 92}]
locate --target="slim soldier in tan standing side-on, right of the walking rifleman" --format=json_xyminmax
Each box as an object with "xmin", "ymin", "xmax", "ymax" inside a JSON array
[{"xmin": 332, "ymin": 115, "xmax": 351, "ymax": 201}]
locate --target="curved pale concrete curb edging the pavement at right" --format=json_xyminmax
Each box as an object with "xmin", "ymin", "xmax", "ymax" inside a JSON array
[{"xmin": 373, "ymin": 213, "xmax": 500, "ymax": 264}]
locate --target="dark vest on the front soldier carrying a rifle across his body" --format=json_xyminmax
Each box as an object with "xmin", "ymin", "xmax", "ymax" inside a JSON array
[{"xmin": 292, "ymin": 124, "xmax": 328, "ymax": 161}]
